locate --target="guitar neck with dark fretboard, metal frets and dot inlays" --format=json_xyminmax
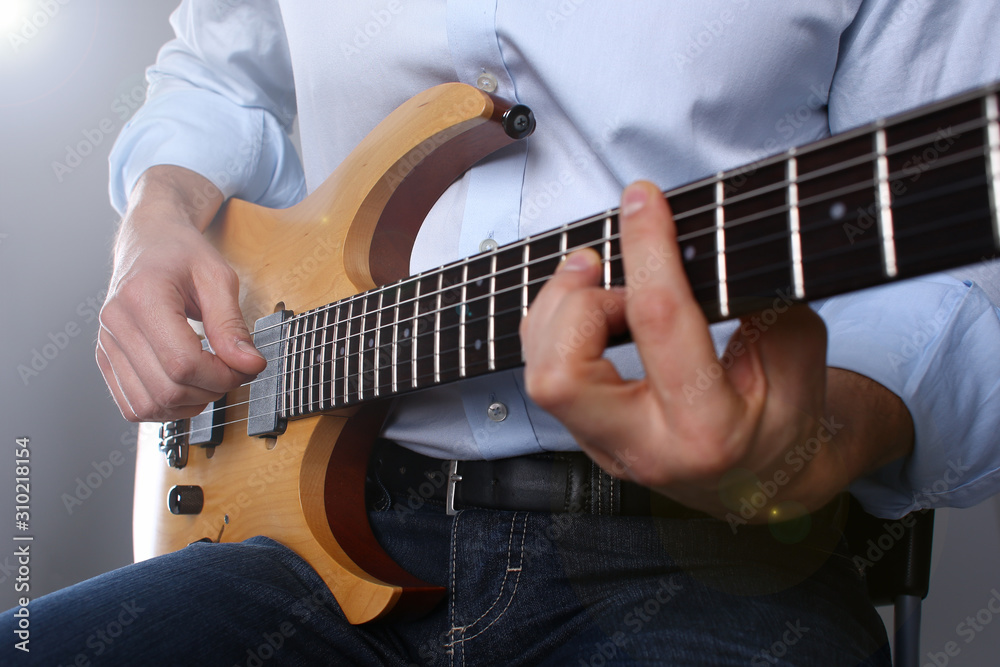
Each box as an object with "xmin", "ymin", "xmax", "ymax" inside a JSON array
[{"xmin": 264, "ymin": 85, "xmax": 1000, "ymax": 419}]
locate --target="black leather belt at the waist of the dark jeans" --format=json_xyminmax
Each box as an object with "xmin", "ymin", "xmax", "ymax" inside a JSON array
[{"xmin": 371, "ymin": 440, "xmax": 707, "ymax": 518}]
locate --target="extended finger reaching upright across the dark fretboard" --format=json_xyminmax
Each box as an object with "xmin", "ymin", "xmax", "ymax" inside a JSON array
[{"xmin": 620, "ymin": 181, "xmax": 734, "ymax": 412}]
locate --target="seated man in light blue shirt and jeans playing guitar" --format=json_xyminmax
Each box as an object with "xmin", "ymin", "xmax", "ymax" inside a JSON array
[{"xmin": 7, "ymin": 0, "xmax": 1000, "ymax": 665}]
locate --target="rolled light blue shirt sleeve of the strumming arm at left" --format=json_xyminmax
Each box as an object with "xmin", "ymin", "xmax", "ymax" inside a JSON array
[{"xmin": 109, "ymin": 0, "xmax": 305, "ymax": 212}]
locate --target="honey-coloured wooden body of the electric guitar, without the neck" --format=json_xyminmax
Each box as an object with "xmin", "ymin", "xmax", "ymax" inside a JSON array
[{"xmin": 133, "ymin": 84, "xmax": 531, "ymax": 623}]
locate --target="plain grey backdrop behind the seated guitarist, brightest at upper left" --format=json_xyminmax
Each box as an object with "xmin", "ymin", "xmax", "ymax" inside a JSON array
[{"xmin": 0, "ymin": 0, "xmax": 1000, "ymax": 665}]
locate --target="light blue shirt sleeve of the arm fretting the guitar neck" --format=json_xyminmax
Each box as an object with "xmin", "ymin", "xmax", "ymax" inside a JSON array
[{"xmin": 819, "ymin": 0, "xmax": 1000, "ymax": 517}]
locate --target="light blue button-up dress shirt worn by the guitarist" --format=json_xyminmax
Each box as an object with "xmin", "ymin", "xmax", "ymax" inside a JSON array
[{"xmin": 111, "ymin": 0, "xmax": 1000, "ymax": 516}]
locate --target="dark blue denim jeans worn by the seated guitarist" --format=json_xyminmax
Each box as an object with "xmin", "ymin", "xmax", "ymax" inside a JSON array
[{"xmin": 0, "ymin": 486, "xmax": 889, "ymax": 667}]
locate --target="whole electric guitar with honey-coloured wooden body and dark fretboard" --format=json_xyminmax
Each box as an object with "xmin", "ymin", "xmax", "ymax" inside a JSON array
[{"xmin": 133, "ymin": 84, "xmax": 1000, "ymax": 623}]
